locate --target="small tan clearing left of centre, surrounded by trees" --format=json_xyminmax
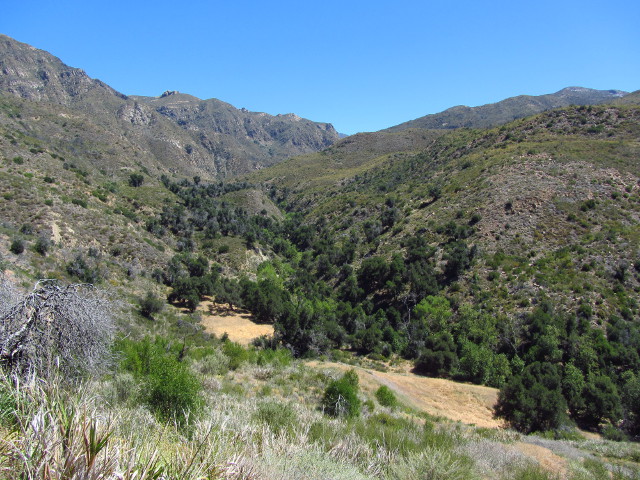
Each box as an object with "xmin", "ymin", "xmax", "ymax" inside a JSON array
[{"xmin": 198, "ymin": 301, "xmax": 273, "ymax": 345}]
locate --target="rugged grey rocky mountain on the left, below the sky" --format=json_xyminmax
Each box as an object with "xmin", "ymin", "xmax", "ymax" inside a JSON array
[{"xmin": 0, "ymin": 36, "xmax": 338, "ymax": 178}]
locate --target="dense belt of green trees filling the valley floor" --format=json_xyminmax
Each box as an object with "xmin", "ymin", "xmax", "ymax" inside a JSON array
[{"xmin": 154, "ymin": 175, "xmax": 640, "ymax": 434}]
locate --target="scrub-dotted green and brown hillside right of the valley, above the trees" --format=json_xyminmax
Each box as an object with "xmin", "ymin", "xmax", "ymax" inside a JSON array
[{"xmin": 250, "ymin": 106, "xmax": 640, "ymax": 320}]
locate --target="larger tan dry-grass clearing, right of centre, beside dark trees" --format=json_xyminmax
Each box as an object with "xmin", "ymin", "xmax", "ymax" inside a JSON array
[{"xmin": 309, "ymin": 362, "xmax": 504, "ymax": 428}]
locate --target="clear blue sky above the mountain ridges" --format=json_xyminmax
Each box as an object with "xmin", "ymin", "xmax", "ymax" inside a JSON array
[{"xmin": 0, "ymin": 0, "xmax": 640, "ymax": 134}]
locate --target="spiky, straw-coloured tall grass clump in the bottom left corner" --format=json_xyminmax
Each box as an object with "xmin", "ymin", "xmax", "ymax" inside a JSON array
[{"xmin": 0, "ymin": 373, "xmax": 125, "ymax": 480}]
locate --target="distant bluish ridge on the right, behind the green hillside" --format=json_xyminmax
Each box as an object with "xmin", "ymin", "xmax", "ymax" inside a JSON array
[{"xmin": 386, "ymin": 87, "xmax": 627, "ymax": 132}]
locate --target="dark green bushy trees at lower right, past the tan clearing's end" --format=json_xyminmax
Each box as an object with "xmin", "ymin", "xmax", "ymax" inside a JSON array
[{"xmin": 497, "ymin": 302, "xmax": 640, "ymax": 434}]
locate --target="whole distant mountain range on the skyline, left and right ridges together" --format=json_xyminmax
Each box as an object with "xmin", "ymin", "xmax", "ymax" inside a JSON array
[{"xmin": 0, "ymin": 31, "xmax": 638, "ymax": 183}]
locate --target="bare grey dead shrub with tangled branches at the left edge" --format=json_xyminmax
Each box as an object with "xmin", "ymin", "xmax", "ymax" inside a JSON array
[{"xmin": 0, "ymin": 279, "xmax": 115, "ymax": 379}]
